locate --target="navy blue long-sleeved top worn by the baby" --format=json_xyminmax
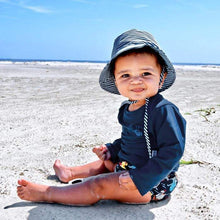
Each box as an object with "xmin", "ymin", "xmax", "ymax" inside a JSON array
[{"xmin": 106, "ymin": 94, "xmax": 186, "ymax": 195}]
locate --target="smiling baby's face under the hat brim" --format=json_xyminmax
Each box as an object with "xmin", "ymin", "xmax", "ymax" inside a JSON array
[{"xmin": 114, "ymin": 53, "xmax": 161, "ymax": 101}]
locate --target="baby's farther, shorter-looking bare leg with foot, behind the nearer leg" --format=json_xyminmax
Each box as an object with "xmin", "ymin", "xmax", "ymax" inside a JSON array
[{"xmin": 53, "ymin": 160, "xmax": 114, "ymax": 182}]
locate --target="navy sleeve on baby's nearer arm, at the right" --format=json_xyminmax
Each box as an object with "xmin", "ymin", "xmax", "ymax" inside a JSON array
[{"xmin": 129, "ymin": 105, "xmax": 186, "ymax": 195}]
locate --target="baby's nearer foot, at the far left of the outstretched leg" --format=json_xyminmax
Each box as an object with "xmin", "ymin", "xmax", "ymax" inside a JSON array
[{"xmin": 17, "ymin": 180, "xmax": 48, "ymax": 202}]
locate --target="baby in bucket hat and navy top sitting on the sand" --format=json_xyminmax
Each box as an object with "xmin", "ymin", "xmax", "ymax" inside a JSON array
[{"xmin": 17, "ymin": 29, "xmax": 186, "ymax": 205}]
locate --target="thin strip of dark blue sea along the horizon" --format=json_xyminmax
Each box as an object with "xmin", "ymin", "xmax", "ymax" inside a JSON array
[{"xmin": 0, "ymin": 59, "xmax": 220, "ymax": 66}]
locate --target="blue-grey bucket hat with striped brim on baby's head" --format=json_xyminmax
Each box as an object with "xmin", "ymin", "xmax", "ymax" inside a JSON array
[{"xmin": 99, "ymin": 29, "xmax": 176, "ymax": 95}]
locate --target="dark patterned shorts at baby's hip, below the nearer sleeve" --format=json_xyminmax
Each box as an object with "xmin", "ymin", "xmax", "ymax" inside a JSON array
[{"xmin": 150, "ymin": 172, "xmax": 178, "ymax": 202}]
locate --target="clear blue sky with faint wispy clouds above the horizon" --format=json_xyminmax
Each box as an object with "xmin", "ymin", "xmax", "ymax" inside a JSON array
[{"xmin": 0, "ymin": 0, "xmax": 220, "ymax": 63}]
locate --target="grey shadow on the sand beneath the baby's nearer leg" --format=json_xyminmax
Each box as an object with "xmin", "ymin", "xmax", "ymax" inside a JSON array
[{"xmin": 4, "ymin": 199, "xmax": 170, "ymax": 220}]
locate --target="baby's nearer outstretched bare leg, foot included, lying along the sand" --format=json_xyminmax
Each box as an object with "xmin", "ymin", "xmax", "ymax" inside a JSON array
[{"xmin": 17, "ymin": 172, "xmax": 151, "ymax": 205}]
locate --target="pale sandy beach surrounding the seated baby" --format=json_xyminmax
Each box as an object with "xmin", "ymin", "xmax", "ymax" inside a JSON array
[{"xmin": 0, "ymin": 62, "xmax": 220, "ymax": 220}]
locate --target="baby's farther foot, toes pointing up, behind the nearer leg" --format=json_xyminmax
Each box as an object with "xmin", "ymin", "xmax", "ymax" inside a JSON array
[{"xmin": 53, "ymin": 160, "xmax": 73, "ymax": 183}]
